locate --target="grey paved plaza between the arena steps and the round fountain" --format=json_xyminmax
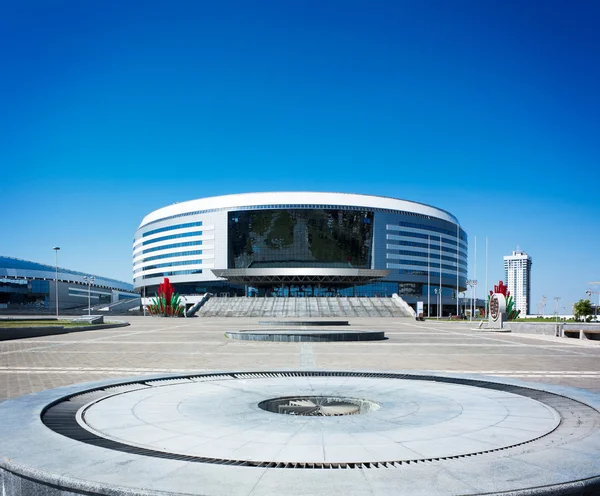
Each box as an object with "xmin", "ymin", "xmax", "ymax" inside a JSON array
[{"xmin": 0, "ymin": 317, "xmax": 600, "ymax": 401}]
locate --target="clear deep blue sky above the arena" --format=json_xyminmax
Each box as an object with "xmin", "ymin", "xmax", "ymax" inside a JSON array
[{"xmin": 0, "ymin": 0, "xmax": 600, "ymax": 313}]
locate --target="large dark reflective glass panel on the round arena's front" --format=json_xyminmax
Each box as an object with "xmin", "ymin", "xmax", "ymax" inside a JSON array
[{"xmin": 228, "ymin": 209, "xmax": 373, "ymax": 268}]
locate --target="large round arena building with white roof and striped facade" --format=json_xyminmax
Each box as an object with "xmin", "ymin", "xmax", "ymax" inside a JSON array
[{"xmin": 133, "ymin": 192, "xmax": 468, "ymax": 315}]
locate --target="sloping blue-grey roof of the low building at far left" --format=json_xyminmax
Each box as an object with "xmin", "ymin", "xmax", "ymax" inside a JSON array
[{"xmin": 0, "ymin": 256, "xmax": 133, "ymax": 292}]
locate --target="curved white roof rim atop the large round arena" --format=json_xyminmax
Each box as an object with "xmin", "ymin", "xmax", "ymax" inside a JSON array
[{"xmin": 140, "ymin": 191, "xmax": 458, "ymax": 227}]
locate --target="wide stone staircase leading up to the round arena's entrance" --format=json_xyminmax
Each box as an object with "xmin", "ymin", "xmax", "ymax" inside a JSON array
[{"xmin": 197, "ymin": 296, "xmax": 413, "ymax": 318}]
